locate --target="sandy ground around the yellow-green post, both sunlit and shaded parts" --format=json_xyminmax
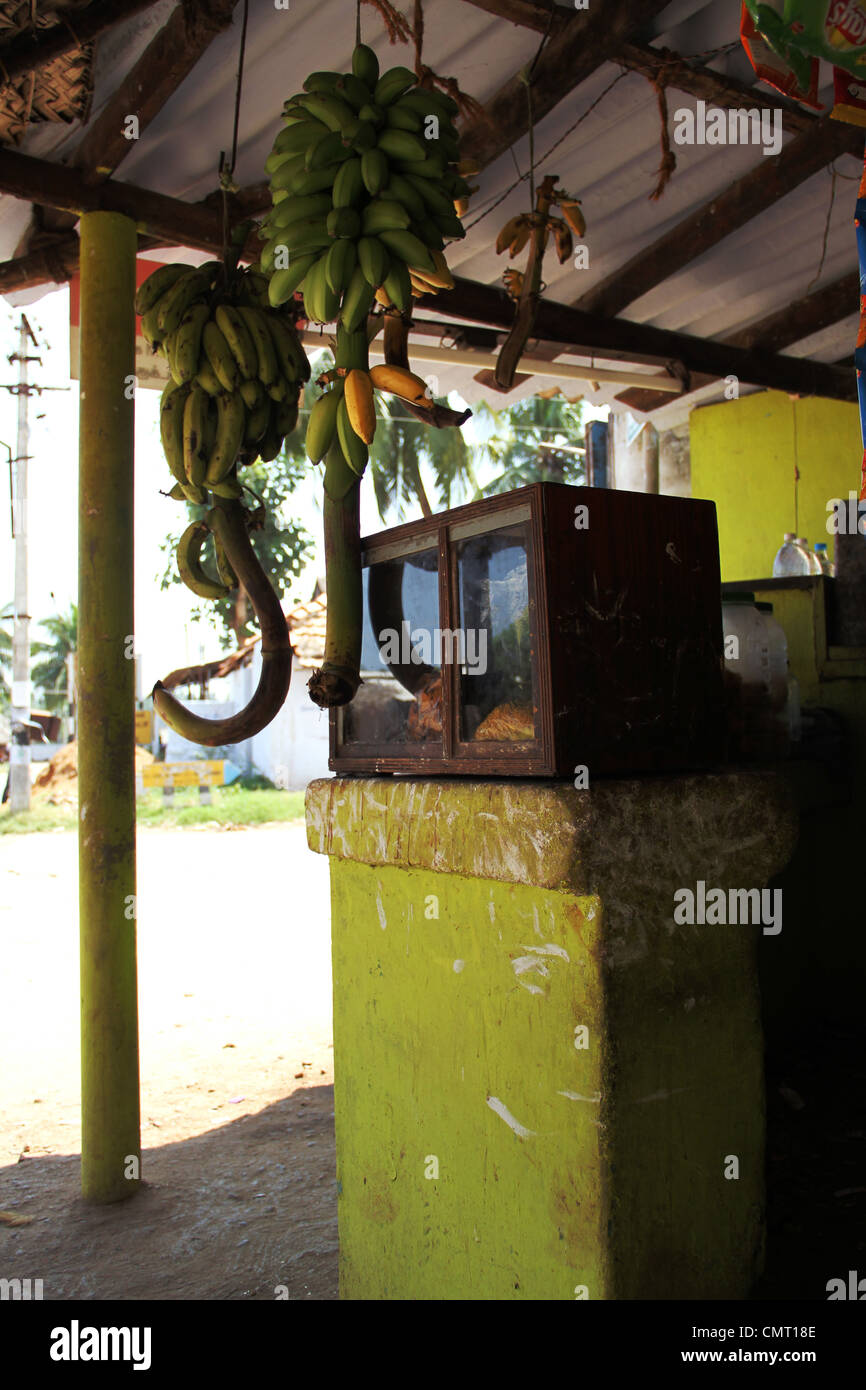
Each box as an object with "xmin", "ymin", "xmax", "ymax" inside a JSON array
[{"xmin": 0, "ymin": 824, "xmax": 336, "ymax": 1298}]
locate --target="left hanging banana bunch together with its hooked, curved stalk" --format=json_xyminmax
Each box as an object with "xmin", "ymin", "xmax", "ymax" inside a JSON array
[{"xmin": 142, "ymin": 261, "xmax": 310, "ymax": 746}]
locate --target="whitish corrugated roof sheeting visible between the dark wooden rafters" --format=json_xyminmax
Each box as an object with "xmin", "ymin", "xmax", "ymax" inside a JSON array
[{"xmin": 0, "ymin": 0, "xmax": 859, "ymax": 425}]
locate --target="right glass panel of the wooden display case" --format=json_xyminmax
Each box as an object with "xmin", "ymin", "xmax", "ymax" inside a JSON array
[{"xmin": 455, "ymin": 524, "xmax": 535, "ymax": 742}]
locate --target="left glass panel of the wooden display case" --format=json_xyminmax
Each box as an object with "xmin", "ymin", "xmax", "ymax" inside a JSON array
[{"xmin": 341, "ymin": 546, "xmax": 442, "ymax": 751}]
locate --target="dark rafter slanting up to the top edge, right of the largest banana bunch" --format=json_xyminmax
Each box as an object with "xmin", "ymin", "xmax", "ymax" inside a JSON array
[{"xmin": 460, "ymin": 0, "xmax": 675, "ymax": 168}]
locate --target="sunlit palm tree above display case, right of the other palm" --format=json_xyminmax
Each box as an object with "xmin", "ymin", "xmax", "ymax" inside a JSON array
[{"xmin": 478, "ymin": 395, "xmax": 587, "ymax": 496}]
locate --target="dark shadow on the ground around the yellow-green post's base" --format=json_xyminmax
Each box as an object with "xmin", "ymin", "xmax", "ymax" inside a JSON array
[{"xmin": 0, "ymin": 1086, "xmax": 338, "ymax": 1300}]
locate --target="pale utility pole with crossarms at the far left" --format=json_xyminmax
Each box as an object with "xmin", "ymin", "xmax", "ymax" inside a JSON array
[{"xmin": 8, "ymin": 314, "xmax": 42, "ymax": 812}]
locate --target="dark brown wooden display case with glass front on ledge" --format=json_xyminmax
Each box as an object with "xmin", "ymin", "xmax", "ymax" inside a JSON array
[{"xmin": 329, "ymin": 482, "xmax": 726, "ymax": 780}]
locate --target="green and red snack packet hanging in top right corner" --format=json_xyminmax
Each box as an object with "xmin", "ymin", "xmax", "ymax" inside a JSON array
[{"xmin": 745, "ymin": 0, "xmax": 866, "ymax": 89}]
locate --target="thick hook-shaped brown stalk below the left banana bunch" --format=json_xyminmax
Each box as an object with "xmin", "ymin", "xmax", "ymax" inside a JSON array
[{"xmin": 153, "ymin": 499, "xmax": 291, "ymax": 748}]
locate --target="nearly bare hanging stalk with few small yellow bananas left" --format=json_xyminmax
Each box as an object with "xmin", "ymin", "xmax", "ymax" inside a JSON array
[{"xmin": 493, "ymin": 175, "xmax": 587, "ymax": 391}]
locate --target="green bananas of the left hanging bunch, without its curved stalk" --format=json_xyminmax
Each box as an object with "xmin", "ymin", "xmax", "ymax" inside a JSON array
[{"xmin": 142, "ymin": 262, "xmax": 315, "ymax": 598}]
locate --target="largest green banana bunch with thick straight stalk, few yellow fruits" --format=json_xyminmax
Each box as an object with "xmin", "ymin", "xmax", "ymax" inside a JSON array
[{"xmin": 261, "ymin": 44, "xmax": 473, "ymax": 708}]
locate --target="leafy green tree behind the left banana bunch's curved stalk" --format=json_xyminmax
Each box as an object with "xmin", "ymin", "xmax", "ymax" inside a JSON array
[{"xmin": 160, "ymin": 447, "xmax": 313, "ymax": 651}]
